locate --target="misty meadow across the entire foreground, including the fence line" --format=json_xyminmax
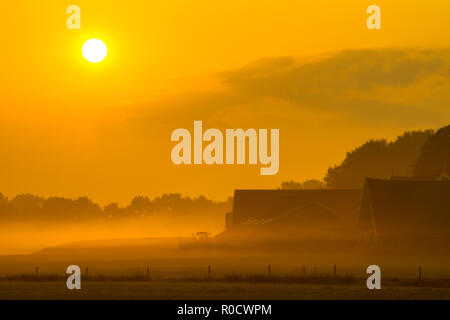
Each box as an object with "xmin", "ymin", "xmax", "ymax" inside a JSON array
[{"xmin": 0, "ymin": 239, "xmax": 450, "ymax": 300}]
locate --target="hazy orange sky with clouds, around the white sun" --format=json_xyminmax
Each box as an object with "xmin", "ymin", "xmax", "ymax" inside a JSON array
[{"xmin": 0, "ymin": 0, "xmax": 450, "ymax": 203}]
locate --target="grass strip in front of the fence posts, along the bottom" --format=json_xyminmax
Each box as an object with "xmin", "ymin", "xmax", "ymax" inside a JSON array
[{"xmin": 0, "ymin": 281, "xmax": 450, "ymax": 300}]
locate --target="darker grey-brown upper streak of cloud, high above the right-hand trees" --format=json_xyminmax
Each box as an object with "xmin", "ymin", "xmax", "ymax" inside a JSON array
[{"xmin": 222, "ymin": 49, "xmax": 450, "ymax": 92}]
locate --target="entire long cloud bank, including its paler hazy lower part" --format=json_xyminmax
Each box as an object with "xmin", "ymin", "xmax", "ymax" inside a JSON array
[{"xmin": 125, "ymin": 49, "xmax": 450, "ymax": 130}]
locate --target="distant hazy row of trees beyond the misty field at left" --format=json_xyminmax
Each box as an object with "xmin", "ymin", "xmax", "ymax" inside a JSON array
[{"xmin": 0, "ymin": 193, "xmax": 232, "ymax": 223}]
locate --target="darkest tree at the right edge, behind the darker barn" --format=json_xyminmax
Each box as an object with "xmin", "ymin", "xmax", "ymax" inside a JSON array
[{"xmin": 412, "ymin": 125, "xmax": 450, "ymax": 179}]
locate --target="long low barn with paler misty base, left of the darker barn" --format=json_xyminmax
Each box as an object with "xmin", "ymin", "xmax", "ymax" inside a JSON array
[{"xmin": 218, "ymin": 189, "xmax": 362, "ymax": 245}]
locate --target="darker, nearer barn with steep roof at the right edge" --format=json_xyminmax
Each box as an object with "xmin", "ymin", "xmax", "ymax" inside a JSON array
[{"xmin": 358, "ymin": 179, "xmax": 450, "ymax": 244}]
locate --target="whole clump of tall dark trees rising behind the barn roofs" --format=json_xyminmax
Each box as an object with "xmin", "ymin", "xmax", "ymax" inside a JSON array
[{"xmin": 324, "ymin": 125, "xmax": 450, "ymax": 189}]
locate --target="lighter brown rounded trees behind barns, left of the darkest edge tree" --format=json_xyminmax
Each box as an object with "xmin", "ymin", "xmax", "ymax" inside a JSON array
[{"xmin": 324, "ymin": 130, "xmax": 433, "ymax": 189}]
